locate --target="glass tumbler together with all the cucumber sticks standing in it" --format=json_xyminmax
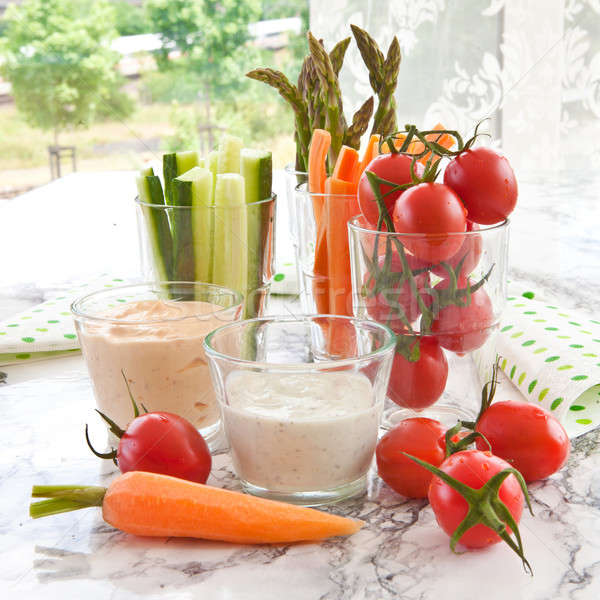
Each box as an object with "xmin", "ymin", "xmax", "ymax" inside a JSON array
[{"xmin": 136, "ymin": 135, "xmax": 276, "ymax": 318}]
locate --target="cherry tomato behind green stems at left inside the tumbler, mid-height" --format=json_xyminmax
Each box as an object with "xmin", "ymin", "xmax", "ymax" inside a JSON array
[{"xmin": 363, "ymin": 252, "xmax": 429, "ymax": 333}]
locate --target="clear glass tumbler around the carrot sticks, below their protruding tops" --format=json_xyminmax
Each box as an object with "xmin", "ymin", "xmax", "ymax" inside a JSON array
[{"xmin": 294, "ymin": 184, "xmax": 360, "ymax": 315}]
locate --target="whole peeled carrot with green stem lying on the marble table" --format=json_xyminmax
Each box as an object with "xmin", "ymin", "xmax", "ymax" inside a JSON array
[{"xmin": 30, "ymin": 471, "xmax": 363, "ymax": 544}]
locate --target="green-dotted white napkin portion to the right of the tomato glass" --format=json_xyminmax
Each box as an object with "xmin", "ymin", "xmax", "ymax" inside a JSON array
[{"xmin": 498, "ymin": 293, "xmax": 600, "ymax": 437}]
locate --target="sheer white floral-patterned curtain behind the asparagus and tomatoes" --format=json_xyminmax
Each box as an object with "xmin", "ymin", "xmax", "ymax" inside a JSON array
[{"xmin": 310, "ymin": 0, "xmax": 600, "ymax": 172}]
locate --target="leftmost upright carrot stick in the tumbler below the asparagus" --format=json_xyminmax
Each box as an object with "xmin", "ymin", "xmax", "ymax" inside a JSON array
[{"xmin": 308, "ymin": 129, "xmax": 331, "ymax": 313}]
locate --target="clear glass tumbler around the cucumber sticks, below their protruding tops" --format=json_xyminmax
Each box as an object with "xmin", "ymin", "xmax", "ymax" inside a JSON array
[{"xmin": 136, "ymin": 194, "xmax": 276, "ymax": 318}]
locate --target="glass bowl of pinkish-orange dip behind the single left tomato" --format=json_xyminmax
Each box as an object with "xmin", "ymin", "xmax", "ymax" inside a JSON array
[{"xmin": 71, "ymin": 282, "xmax": 243, "ymax": 446}]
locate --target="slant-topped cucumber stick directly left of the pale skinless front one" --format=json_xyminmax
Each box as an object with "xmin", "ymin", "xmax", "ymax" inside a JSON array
[{"xmin": 173, "ymin": 167, "xmax": 214, "ymax": 282}]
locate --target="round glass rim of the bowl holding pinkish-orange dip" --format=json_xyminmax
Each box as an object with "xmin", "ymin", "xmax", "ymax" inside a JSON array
[{"xmin": 69, "ymin": 281, "xmax": 244, "ymax": 326}]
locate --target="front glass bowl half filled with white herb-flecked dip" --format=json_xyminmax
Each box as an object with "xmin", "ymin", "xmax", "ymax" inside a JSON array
[{"xmin": 204, "ymin": 315, "xmax": 395, "ymax": 506}]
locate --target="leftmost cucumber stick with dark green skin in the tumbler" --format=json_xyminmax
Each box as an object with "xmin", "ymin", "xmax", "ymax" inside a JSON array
[{"xmin": 136, "ymin": 167, "xmax": 173, "ymax": 281}]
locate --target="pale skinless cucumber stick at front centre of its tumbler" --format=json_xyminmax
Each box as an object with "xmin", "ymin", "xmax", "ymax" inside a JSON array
[{"xmin": 212, "ymin": 173, "xmax": 248, "ymax": 294}]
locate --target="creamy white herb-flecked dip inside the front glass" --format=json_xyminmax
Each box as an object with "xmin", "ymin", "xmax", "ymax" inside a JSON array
[{"xmin": 223, "ymin": 371, "xmax": 381, "ymax": 492}]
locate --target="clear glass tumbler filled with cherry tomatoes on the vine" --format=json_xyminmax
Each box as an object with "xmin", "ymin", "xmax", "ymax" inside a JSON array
[{"xmin": 348, "ymin": 217, "xmax": 508, "ymax": 425}]
